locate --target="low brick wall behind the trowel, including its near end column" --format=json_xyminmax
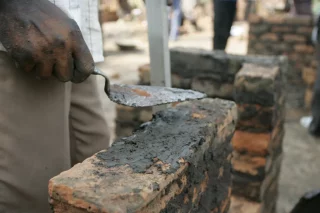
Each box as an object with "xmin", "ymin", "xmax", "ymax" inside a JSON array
[{"xmin": 116, "ymin": 48, "xmax": 287, "ymax": 213}]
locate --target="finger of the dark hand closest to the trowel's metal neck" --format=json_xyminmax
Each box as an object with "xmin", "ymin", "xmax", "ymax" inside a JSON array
[{"xmin": 71, "ymin": 29, "xmax": 94, "ymax": 83}]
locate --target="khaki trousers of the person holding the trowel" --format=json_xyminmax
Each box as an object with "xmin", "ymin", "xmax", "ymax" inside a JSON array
[{"xmin": 0, "ymin": 52, "xmax": 109, "ymax": 213}]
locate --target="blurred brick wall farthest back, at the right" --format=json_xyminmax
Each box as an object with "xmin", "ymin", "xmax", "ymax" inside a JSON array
[{"xmin": 248, "ymin": 15, "xmax": 316, "ymax": 108}]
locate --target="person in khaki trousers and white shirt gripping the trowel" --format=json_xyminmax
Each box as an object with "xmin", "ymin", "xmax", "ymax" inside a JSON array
[{"xmin": 0, "ymin": 0, "xmax": 109, "ymax": 213}]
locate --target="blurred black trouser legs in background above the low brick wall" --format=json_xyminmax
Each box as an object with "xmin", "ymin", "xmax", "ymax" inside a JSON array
[{"xmin": 213, "ymin": 0, "xmax": 237, "ymax": 50}]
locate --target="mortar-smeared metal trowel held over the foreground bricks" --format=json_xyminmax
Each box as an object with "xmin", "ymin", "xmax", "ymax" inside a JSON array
[{"xmin": 92, "ymin": 67, "xmax": 206, "ymax": 107}]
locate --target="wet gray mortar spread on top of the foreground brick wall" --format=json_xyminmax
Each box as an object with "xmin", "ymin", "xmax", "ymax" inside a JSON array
[{"xmin": 97, "ymin": 99, "xmax": 234, "ymax": 173}]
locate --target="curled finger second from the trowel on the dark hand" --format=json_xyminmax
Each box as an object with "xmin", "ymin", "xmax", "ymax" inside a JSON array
[{"xmin": 53, "ymin": 54, "xmax": 74, "ymax": 82}]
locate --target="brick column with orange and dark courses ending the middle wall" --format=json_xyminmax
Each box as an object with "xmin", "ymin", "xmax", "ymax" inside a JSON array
[{"xmin": 232, "ymin": 64, "xmax": 285, "ymax": 213}]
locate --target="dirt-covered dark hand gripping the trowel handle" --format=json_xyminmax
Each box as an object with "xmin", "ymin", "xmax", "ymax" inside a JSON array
[{"xmin": 0, "ymin": 0, "xmax": 94, "ymax": 83}]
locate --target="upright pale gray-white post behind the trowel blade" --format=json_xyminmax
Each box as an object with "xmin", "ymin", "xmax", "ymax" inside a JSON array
[{"xmin": 146, "ymin": 0, "xmax": 171, "ymax": 112}]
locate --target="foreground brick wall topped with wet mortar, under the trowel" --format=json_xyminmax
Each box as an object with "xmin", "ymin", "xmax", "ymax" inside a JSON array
[{"xmin": 49, "ymin": 99, "xmax": 237, "ymax": 213}]
